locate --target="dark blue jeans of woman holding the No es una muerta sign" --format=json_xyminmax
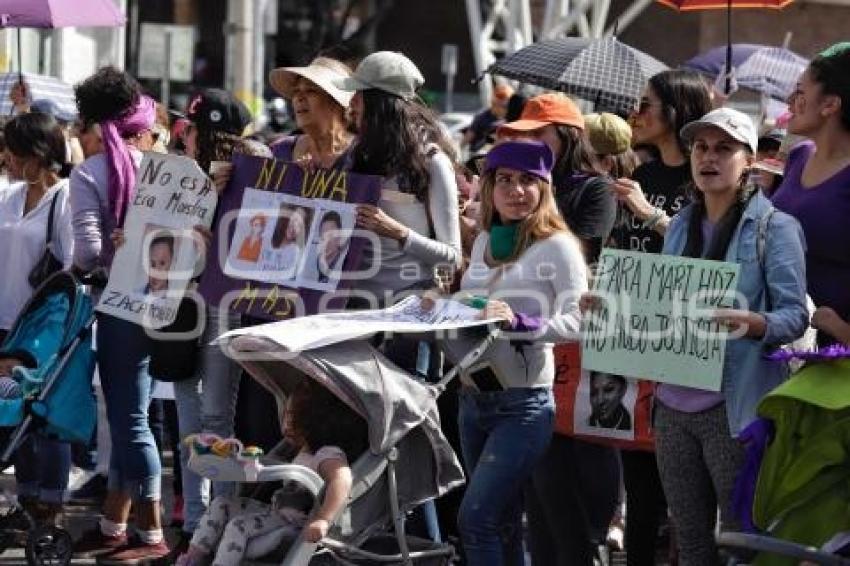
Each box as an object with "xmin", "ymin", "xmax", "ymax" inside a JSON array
[{"xmin": 97, "ymin": 313, "xmax": 162, "ymax": 501}]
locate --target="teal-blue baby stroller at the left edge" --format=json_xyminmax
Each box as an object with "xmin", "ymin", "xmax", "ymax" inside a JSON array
[{"xmin": 0, "ymin": 272, "xmax": 96, "ymax": 565}]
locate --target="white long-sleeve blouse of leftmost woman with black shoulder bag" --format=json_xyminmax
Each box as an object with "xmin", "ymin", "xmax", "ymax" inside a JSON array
[{"xmin": 0, "ymin": 179, "xmax": 74, "ymax": 330}]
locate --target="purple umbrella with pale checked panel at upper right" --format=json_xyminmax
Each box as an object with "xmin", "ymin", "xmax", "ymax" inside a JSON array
[{"xmin": 683, "ymin": 43, "xmax": 809, "ymax": 100}]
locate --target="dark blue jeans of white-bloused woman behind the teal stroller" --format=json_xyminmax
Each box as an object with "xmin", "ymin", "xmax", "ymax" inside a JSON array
[{"xmin": 14, "ymin": 432, "xmax": 71, "ymax": 503}]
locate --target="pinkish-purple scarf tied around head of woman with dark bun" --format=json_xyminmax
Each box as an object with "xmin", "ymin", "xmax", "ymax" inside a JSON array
[{"xmin": 100, "ymin": 95, "xmax": 156, "ymax": 226}]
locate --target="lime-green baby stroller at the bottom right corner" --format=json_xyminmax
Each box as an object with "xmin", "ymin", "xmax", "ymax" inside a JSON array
[{"xmin": 718, "ymin": 359, "xmax": 850, "ymax": 566}]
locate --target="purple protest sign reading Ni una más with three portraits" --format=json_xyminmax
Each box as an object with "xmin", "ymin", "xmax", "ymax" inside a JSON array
[{"xmin": 199, "ymin": 154, "xmax": 381, "ymax": 320}]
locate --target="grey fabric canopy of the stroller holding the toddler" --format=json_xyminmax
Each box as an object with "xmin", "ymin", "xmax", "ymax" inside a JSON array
[{"xmin": 229, "ymin": 336, "xmax": 463, "ymax": 508}]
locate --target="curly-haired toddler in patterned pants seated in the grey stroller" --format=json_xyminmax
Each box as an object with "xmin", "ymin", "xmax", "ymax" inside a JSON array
[{"xmin": 177, "ymin": 379, "xmax": 368, "ymax": 566}]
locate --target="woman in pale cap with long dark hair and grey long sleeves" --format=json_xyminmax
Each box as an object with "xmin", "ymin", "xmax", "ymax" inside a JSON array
[{"xmin": 336, "ymin": 51, "xmax": 461, "ymax": 540}]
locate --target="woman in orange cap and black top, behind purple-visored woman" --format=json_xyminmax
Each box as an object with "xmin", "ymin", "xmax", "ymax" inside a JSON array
[{"xmin": 499, "ymin": 93, "xmax": 617, "ymax": 263}]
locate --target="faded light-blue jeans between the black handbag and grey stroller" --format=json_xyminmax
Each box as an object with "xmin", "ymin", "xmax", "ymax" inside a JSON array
[{"xmin": 174, "ymin": 306, "xmax": 242, "ymax": 533}]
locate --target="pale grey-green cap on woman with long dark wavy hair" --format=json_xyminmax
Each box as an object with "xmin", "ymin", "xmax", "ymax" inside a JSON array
[{"xmin": 334, "ymin": 51, "xmax": 425, "ymax": 100}]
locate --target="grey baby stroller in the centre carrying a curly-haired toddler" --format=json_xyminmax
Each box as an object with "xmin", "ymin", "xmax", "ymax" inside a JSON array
[{"xmin": 189, "ymin": 326, "xmax": 496, "ymax": 566}]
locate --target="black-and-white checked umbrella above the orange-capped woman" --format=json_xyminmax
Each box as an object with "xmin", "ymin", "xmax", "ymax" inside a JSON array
[{"xmin": 486, "ymin": 37, "xmax": 667, "ymax": 114}]
